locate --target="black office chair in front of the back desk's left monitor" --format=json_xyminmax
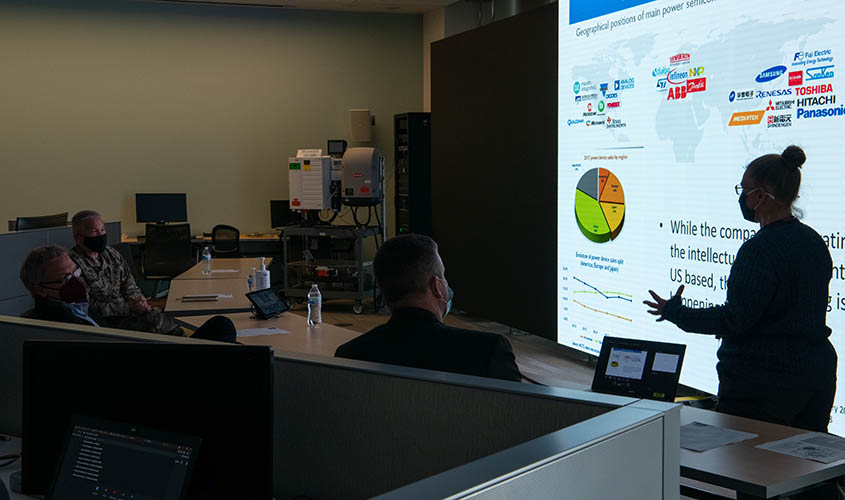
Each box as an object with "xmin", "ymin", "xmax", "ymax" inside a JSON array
[{"xmin": 141, "ymin": 224, "xmax": 194, "ymax": 297}]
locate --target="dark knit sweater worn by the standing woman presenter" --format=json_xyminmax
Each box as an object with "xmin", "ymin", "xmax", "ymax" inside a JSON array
[{"xmin": 663, "ymin": 218, "xmax": 836, "ymax": 389}]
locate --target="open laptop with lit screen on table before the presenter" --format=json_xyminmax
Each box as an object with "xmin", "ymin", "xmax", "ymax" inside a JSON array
[{"xmin": 592, "ymin": 337, "xmax": 687, "ymax": 401}]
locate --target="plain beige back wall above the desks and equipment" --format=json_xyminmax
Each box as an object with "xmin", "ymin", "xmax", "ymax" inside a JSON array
[{"xmin": 0, "ymin": 0, "xmax": 423, "ymax": 234}]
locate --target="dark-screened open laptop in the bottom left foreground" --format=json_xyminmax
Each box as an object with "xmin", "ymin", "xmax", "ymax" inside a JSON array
[{"xmin": 46, "ymin": 416, "xmax": 201, "ymax": 500}]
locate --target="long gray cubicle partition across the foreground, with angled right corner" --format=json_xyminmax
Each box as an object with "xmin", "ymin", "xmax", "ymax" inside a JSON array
[{"xmin": 0, "ymin": 317, "xmax": 680, "ymax": 500}]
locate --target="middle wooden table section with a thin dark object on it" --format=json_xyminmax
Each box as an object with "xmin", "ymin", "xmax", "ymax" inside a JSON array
[{"xmin": 164, "ymin": 278, "xmax": 252, "ymax": 316}]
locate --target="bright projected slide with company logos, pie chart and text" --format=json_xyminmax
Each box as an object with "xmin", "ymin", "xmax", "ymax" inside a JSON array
[{"xmin": 557, "ymin": 0, "xmax": 845, "ymax": 435}]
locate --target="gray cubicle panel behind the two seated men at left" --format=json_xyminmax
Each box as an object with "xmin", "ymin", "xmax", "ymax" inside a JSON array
[{"xmin": 0, "ymin": 222, "xmax": 120, "ymax": 316}]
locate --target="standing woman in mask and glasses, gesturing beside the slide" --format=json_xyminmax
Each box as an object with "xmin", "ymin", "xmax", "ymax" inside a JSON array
[{"xmin": 644, "ymin": 146, "xmax": 837, "ymax": 432}]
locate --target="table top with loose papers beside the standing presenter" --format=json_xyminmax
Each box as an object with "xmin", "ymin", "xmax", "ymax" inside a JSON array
[{"xmin": 681, "ymin": 406, "xmax": 845, "ymax": 498}]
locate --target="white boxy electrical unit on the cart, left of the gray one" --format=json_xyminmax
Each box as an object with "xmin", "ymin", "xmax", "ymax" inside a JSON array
[{"xmin": 288, "ymin": 149, "xmax": 332, "ymax": 210}]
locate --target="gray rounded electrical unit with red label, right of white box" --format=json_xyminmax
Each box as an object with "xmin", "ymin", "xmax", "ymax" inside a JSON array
[{"xmin": 343, "ymin": 148, "xmax": 384, "ymax": 207}]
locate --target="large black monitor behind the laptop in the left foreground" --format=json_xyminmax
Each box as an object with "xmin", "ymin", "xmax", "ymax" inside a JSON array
[{"xmin": 21, "ymin": 341, "xmax": 273, "ymax": 500}]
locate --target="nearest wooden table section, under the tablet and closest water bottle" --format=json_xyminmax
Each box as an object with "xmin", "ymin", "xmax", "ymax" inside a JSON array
[{"xmin": 179, "ymin": 312, "xmax": 361, "ymax": 356}]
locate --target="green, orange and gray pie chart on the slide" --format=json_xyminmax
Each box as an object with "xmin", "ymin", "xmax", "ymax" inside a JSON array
[{"xmin": 575, "ymin": 168, "xmax": 625, "ymax": 243}]
